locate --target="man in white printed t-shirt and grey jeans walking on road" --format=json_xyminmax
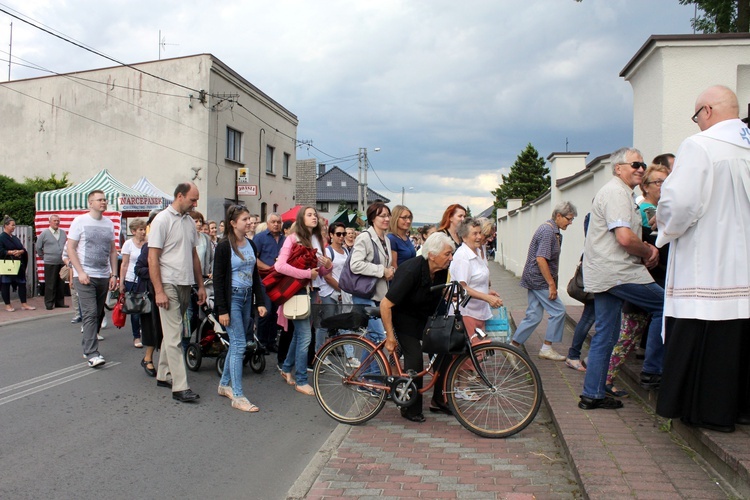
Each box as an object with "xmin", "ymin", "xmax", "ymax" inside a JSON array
[{"xmin": 68, "ymin": 189, "xmax": 117, "ymax": 368}]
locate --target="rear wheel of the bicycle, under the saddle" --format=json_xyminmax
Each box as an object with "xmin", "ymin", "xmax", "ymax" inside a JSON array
[{"xmin": 313, "ymin": 337, "xmax": 388, "ymax": 425}]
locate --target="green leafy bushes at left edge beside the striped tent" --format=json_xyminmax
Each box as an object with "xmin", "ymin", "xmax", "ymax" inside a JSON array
[{"xmin": 0, "ymin": 172, "xmax": 70, "ymax": 226}]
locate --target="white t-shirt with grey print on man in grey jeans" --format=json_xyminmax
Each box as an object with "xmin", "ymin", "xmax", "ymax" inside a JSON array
[{"xmin": 68, "ymin": 214, "xmax": 115, "ymax": 278}]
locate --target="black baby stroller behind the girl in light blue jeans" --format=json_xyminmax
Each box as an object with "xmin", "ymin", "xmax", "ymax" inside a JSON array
[{"xmin": 185, "ymin": 279, "xmax": 266, "ymax": 376}]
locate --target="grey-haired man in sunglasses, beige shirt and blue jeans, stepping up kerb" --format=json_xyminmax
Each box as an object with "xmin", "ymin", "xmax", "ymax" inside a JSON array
[{"xmin": 578, "ymin": 148, "xmax": 664, "ymax": 410}]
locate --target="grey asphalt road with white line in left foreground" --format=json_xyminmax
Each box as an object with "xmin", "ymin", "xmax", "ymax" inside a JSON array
[{"xmin": 0, "ymin": 315, "xmax": 336, "ymax": 499}]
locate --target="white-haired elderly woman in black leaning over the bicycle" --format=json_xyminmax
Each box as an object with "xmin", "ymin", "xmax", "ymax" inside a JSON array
[{"xmin": 380, "ymin": 233, "xmax": 454, "ymax": 422}]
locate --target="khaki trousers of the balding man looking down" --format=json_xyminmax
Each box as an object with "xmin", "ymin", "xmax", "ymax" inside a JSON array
[{"xmin": 156, "ymin": 283, "xmax": 190, "ymax": 392}]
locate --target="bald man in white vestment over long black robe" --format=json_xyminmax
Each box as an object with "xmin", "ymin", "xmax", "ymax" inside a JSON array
[{"xmin": 656, "ymin": 86, "xmax": 750, "ymax": 432}]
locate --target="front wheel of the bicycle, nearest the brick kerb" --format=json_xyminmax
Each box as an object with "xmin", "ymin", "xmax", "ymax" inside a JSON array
[{"xmin": 445, "ymin": 341, "xmax": 542, "ymax": 438}]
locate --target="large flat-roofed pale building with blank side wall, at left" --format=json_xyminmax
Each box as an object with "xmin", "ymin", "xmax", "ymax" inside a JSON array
[{"xmin": 0, "ymin": 54, "xmax": 298, "ymax": 220}]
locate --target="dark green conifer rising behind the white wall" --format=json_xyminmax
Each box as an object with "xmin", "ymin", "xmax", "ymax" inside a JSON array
[{"xmin": 492, "ymin": 143, "xmax": 551, "ymax": 208}]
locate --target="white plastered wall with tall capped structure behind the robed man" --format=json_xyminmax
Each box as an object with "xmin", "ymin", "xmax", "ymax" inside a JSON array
[{"xmin": 495, "ymin": 33, "xmax": 750, "ymax": 305}]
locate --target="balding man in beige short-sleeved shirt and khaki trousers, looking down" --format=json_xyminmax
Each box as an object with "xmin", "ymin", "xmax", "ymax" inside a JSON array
[{"xmin": 148, "ymin": 182, "xmax": 206, "ymax": 403}]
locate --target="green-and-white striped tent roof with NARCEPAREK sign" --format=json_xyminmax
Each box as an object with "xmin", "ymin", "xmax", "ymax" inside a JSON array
[{"xmin": 36, "ymin": 169, "xmax": 164, "ymax": 212}]
